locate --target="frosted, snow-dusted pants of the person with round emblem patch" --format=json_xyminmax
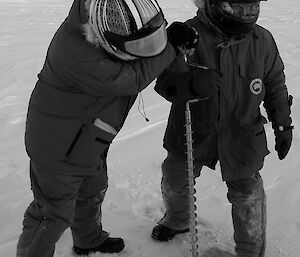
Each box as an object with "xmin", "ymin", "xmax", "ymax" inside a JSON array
[{"xmin": 158, "ymin": 153, "xmax": 266, "ymax": 257}]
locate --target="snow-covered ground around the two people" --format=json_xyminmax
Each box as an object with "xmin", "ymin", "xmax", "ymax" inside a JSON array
[{"xmin": 0, "ymin": 0, "xmax": 300, "ymax": 257}]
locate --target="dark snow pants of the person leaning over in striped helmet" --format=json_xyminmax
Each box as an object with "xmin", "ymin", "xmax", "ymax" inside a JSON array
[{"xmin": 17, "ymin": 161, "xmax": 108, "ymax": 257}]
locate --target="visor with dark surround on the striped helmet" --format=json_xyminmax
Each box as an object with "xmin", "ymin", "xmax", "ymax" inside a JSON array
[{"xmin": 104, "ymin": 12, "xmax": 168, "ymax": 57}]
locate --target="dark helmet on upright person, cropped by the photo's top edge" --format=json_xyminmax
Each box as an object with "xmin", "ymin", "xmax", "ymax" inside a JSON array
[{"xmin": 206, "ymin": 0, "xmax": 266, "ymax": 36}]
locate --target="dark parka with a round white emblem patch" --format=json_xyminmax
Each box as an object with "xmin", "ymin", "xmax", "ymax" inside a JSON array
[{"xmin": 155, "ymin": 9, "xmax": 291, "ymax": 181}]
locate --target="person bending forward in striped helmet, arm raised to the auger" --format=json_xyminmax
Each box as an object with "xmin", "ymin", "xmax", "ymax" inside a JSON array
[{"xmin": 17, "ymin": 0, "xmax": 197, "ymax": 257}]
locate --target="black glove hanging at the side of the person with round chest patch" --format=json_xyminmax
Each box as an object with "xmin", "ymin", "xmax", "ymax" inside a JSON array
[{"xmin": 274, "ymin": 126, "xmax": 294, "ymax": 160}]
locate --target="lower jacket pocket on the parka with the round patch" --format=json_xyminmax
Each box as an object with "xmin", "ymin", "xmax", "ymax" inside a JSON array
[{"xmin": 242, "ymin": 116, "xmax": 270, "ymax": 165}]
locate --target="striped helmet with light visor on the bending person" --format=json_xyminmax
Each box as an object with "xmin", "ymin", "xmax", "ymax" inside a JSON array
[{"xmin": 89, "ymin": 0, "xmax": 167, "ymax": 60}]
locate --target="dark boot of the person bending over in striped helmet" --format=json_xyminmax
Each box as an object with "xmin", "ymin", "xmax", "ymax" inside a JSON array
[{"xmin": 73, "ymin": 237, "xmax": 125, "ymax": 256}]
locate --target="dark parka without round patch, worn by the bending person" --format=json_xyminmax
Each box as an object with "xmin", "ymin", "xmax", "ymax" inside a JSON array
[{"xmin": 25, "ymin": 0, "xmax": 175, "ymax": 174}]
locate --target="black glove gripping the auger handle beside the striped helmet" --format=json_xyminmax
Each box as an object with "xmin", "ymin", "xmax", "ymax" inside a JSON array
[{"xmin": 167, "ymin": 21, "xmax": 199, "ymax": 54}]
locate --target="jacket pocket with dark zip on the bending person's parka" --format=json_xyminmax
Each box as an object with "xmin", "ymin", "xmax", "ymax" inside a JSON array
[{"xmin": 66, "ymin": 123, "xmax": 115, "ymax": 167}]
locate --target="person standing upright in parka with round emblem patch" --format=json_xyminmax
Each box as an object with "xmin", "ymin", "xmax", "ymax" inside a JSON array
[{"xmin": 152, "ymin": 0, "xmax": 293, "ymax": 257}]
